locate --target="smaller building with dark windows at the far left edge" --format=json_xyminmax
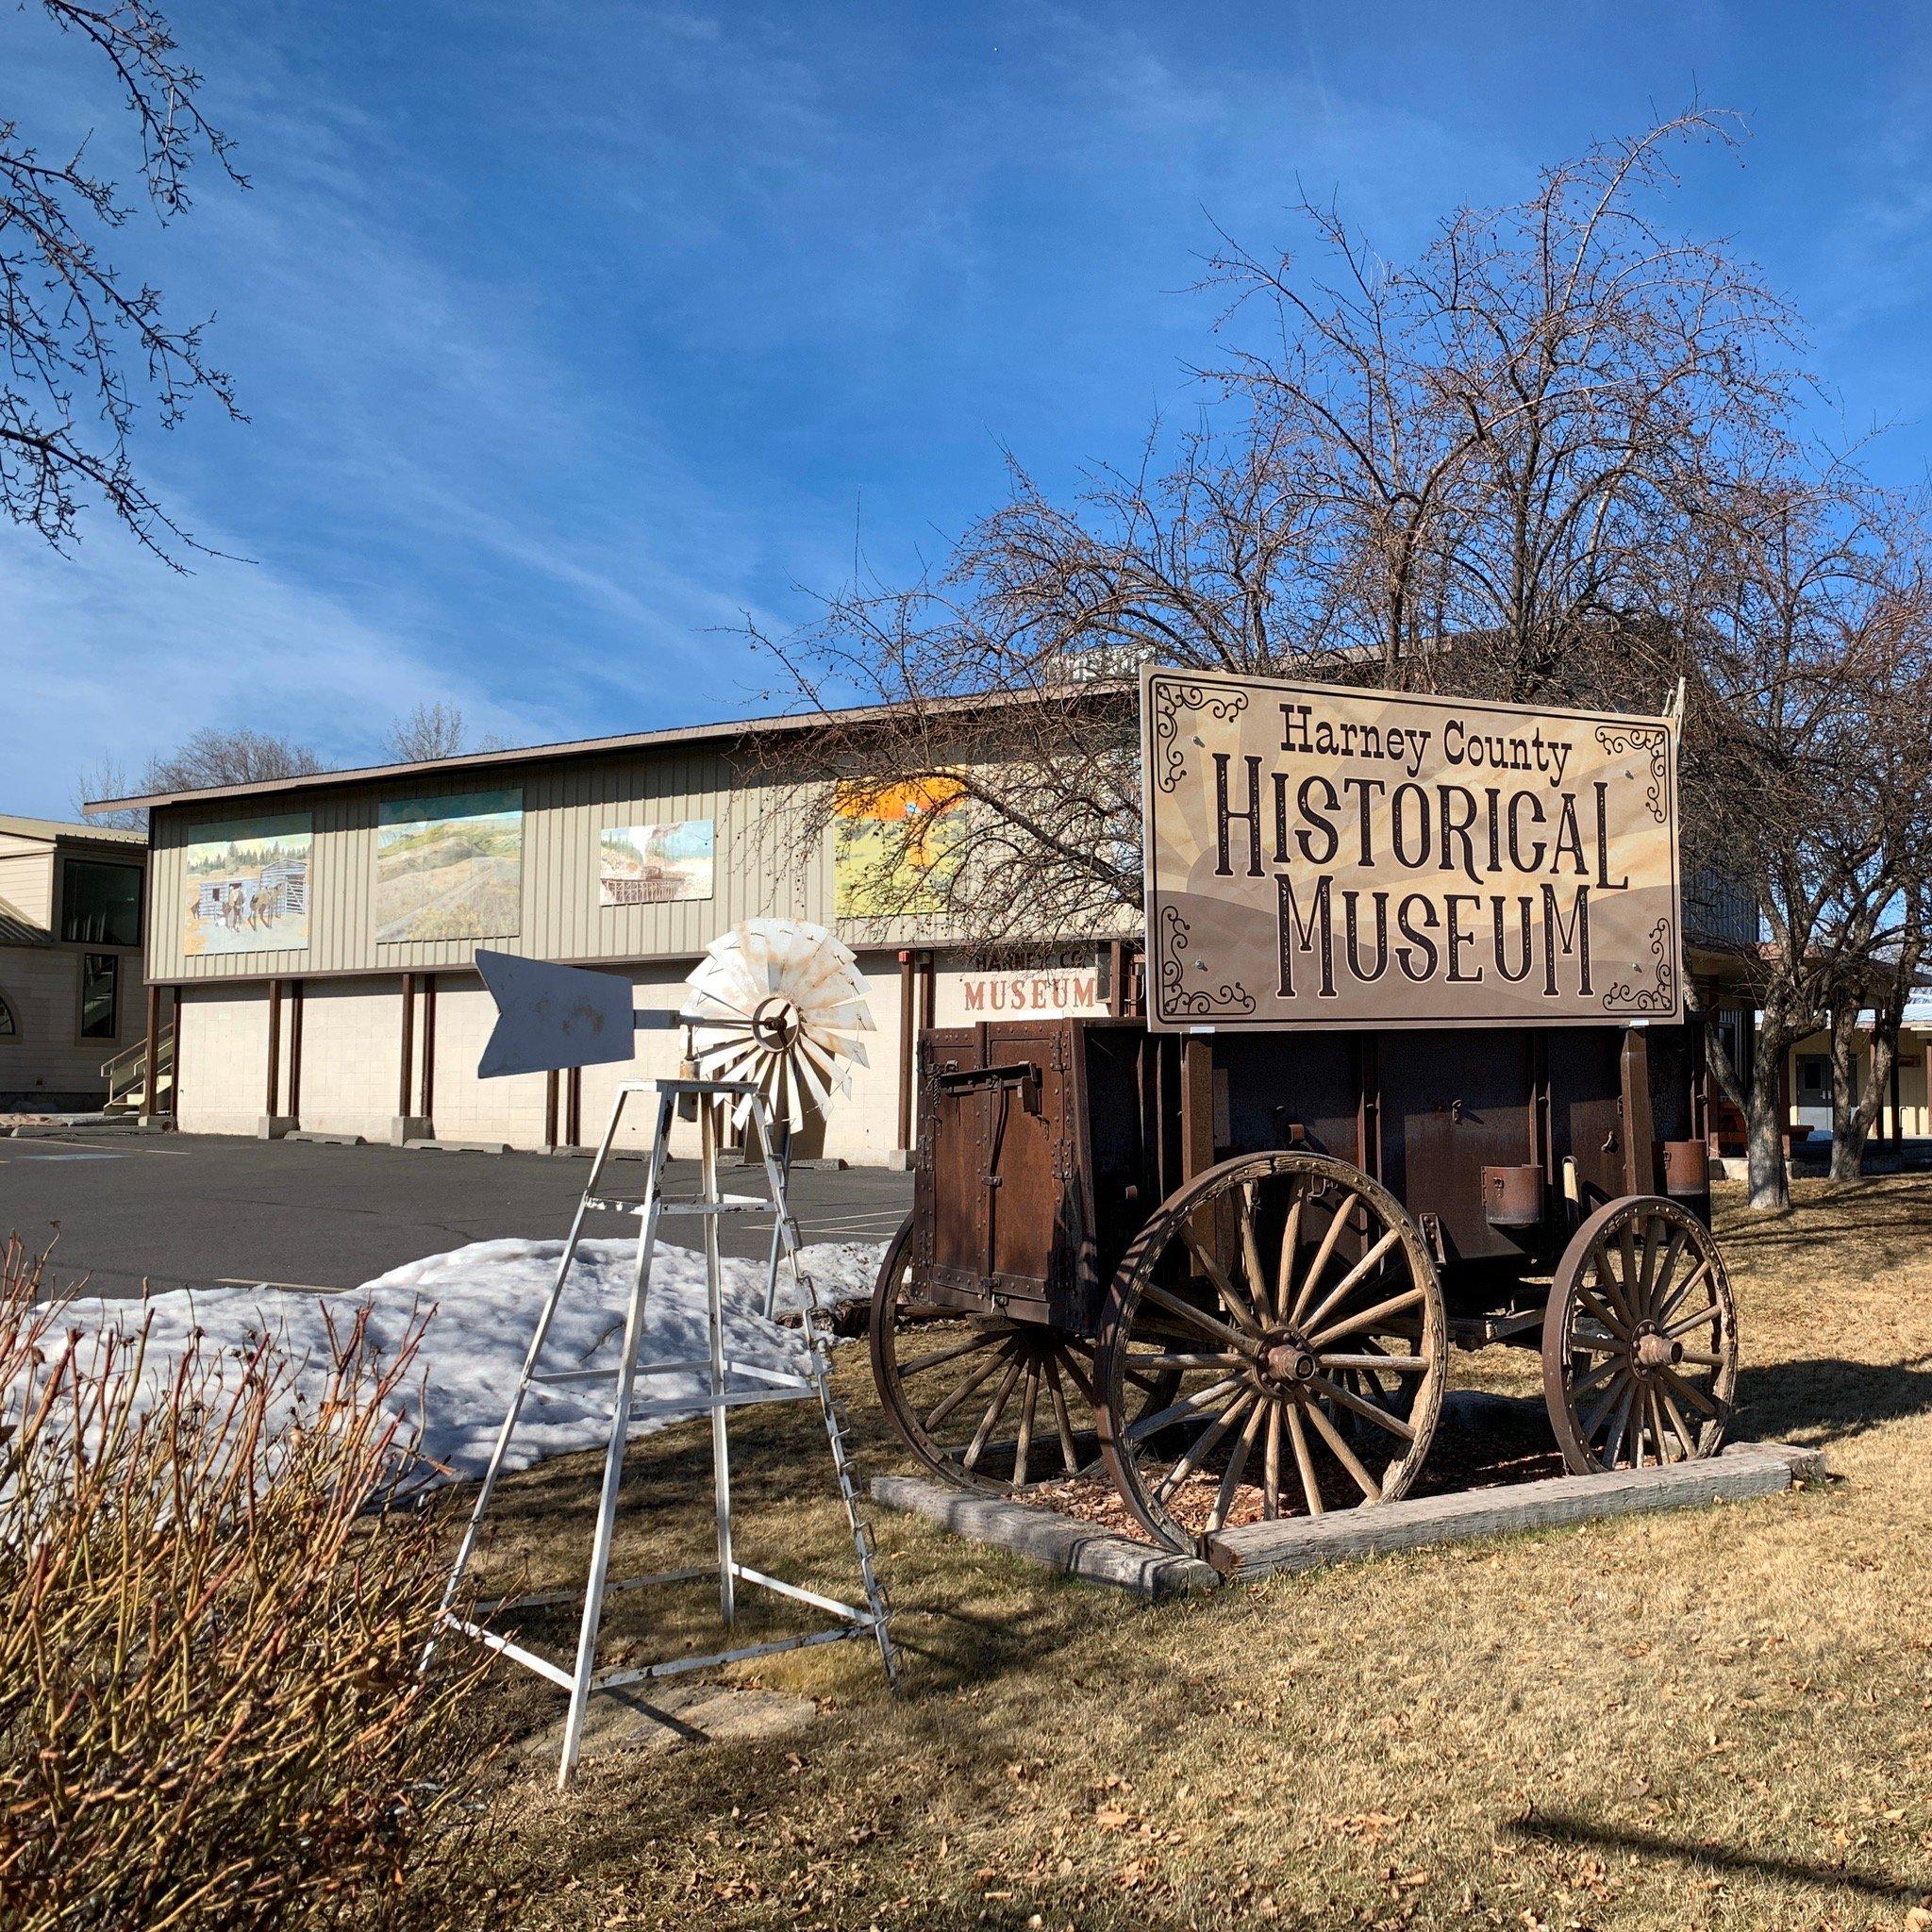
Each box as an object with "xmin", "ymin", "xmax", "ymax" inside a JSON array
[{"xmin": 0, "ymin": 815, "xmax": 154, "ymax": 1109}]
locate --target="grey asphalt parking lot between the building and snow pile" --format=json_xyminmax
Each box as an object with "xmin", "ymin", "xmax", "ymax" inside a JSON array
[{"xmin": 0, "ymin": 1130, "xmax": 912, "ymax": 1294}]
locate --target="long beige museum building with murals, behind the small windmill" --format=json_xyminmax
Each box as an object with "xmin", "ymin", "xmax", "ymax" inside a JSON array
[{"xmin": 102, "ymin": 719, "xmax": 1132, "ymax": 1165}]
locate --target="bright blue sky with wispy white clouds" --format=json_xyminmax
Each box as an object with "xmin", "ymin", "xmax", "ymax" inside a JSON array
[{"xmin": 0, "ymin": 0, "xmax": 1932, "ymax": 815}]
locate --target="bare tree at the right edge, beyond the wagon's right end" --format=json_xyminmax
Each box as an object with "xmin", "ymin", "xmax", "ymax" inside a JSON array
[{"xmin": 1641, "ymin": 464, "xmax": 1932, "ymax": 1208}]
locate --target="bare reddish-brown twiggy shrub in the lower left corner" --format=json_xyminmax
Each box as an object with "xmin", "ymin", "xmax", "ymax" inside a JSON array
[{"xmin": 0, "ymin": 1239, "xmax": 506, "ymax": 1932}]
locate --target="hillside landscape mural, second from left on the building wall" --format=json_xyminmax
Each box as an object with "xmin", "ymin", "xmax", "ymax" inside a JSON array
[{"xmin": 375, "ymin": 791, "xmax": 524, "ymax": 947}]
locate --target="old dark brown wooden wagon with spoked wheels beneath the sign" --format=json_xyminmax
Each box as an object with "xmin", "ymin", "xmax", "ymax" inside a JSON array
[{"xmin": 872, "ymin": 668, "xmax": 1737, "ymax": 1549}]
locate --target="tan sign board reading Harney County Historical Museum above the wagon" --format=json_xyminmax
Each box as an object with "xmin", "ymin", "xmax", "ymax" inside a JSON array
[{"xmin": 1140, "ymin": 671, "xmax": 1681, "ymax": 1028}]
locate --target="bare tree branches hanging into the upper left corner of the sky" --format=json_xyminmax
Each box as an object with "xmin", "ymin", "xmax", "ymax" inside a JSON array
[{"xmin": 0, "ymin": 0, "xmax": 247, "ymax": 562}]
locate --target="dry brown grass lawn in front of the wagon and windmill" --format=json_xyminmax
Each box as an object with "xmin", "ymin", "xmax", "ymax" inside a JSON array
[{"xmin": 456, "ymin": 1178, "xmax": 1932, "ymax": 1928}]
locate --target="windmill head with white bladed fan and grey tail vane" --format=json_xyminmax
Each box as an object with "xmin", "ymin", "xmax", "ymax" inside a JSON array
[{"xmin": 475, "ymin": 920, "xmax": 872, "ymax": 1132}]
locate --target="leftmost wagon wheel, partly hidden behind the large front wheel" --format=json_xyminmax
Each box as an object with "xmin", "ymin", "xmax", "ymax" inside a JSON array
[{"xmin": 872, "ymin": 1217, "xmax": 1120, "ymax": 1495}]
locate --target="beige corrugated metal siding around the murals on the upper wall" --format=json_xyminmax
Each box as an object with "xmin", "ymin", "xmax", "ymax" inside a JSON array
[{"xmin": 151, "ymin": 750, "xmax": 833, "ymax": 981}]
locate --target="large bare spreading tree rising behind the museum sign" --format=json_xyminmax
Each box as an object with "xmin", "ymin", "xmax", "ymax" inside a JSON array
[{"xmin": 754, "ymin": 110, "xmax": 1797, "ymax": 939}]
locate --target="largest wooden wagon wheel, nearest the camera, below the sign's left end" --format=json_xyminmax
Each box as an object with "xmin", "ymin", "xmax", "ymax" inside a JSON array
[{"xmin": 1099, "ymin": 1150, "xmax": 1449, "ymax": 1549}]
